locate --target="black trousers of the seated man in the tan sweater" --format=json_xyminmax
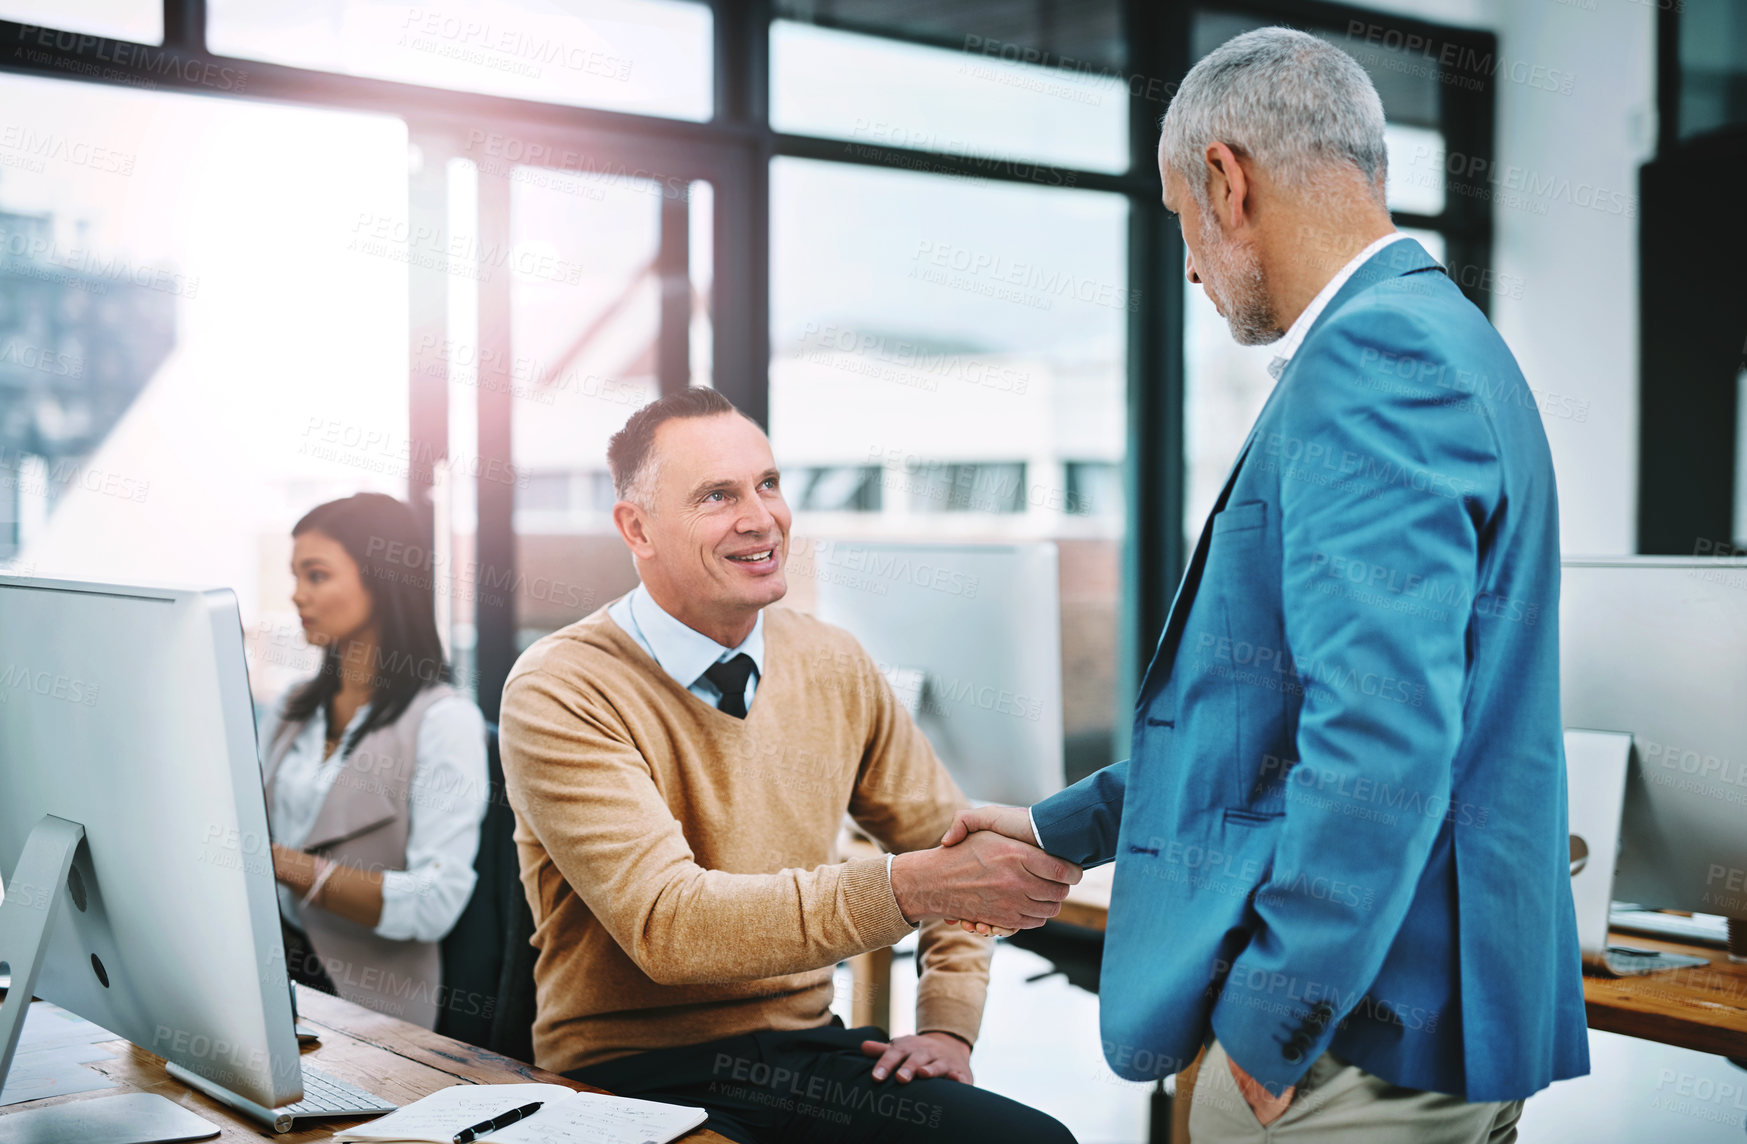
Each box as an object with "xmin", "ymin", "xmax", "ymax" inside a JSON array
[{"xmin": 566, "ymin": 1018, "xmax": 1074, "ymax": 1144}]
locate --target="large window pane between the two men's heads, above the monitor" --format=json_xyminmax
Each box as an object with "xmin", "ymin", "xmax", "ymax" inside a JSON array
[{"xmin": 770, "ymin": 159, "xmax": 1141, "ymax": 774}]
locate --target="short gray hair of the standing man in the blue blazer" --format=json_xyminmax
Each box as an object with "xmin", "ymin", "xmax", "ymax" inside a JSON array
[{"xmin": 1164, "ymin": 28, "xmax": 1389, "ymax": 210}]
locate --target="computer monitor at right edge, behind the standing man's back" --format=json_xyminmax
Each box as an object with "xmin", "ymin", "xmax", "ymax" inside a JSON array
[{"xmin": 1558, "ymin": 557, "xmax": 1747, "ymax": 919}]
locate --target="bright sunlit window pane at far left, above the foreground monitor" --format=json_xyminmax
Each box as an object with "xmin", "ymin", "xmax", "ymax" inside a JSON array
[{"xmin": 0, "ymin": 75, "xmax": 408, "ymax": 700}]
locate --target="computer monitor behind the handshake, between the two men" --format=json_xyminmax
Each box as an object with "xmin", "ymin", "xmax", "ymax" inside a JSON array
[{"xmin": 812, "ymin": 540, "xmax": 1064, "ymax": 805}]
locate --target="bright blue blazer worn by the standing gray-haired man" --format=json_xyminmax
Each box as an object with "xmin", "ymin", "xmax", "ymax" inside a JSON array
[{"xmin": 1032, "ymin": 239, "xmax": 1588, "ymax": 1100}]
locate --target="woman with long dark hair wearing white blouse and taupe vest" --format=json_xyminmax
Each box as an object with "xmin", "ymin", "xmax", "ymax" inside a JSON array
[{"xmin": 262, "ymin": 493, "xmax": 487, "ymax": 1029}]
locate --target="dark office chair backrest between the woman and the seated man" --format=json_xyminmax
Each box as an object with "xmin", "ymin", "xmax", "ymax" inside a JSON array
[{"xmin": 437, "ymin": 723, "xmax": 535, "ymax": 1062}]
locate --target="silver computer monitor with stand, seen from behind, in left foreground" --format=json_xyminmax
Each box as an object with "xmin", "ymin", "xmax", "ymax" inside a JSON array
[{"xmin": 0, "ymin": 576, "xmax": 302, "ymax": 1144}]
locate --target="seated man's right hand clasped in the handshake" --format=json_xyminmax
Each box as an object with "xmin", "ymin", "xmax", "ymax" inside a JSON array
[{"xmin": 891, "ymin": 831, "xmax": 1081, "ymax": 929}]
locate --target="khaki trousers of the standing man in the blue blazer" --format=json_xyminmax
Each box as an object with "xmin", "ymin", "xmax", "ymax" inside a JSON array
[{"xmin": 1190, "ymin": 1041, "xmax": 1523, "ymax": 1144}]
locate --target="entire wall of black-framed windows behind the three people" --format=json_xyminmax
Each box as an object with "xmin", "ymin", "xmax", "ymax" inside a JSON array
[{"xmin": 0, "ymin": 0, "xmax": 1488, "ymax": 761}]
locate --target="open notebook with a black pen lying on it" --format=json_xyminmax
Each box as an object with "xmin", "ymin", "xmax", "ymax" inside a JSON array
[{"xmin": 334, "ymin": 1085, "xmax": 709, "ymax": 1144}]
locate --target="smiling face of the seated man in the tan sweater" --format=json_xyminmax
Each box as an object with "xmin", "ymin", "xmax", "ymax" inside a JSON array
[{"xmin": 613, "ymin": 414, "xmax": 790, "ymax": 648}]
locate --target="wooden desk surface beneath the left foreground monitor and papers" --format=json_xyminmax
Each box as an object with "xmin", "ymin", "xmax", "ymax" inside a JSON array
[{"xmin": 5, "ymin": 989, "xmax": 728, "ymax": 1144}]
